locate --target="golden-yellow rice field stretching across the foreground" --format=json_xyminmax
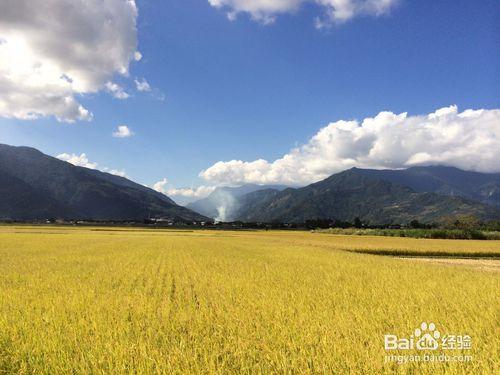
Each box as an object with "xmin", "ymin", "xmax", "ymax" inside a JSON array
[{"xmin": 0, "ymin": 226, "xmax": 500, "ymax": 374}]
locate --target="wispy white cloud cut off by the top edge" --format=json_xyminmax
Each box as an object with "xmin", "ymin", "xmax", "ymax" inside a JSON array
[{"xmin": 208, "ymin": 0, "xmax": 399, "ymax": 27}]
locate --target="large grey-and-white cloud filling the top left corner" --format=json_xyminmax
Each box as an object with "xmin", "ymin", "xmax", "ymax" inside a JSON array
[{"xmin": 0, "ymin": 0, "xmax": 141, "ymax": 122}]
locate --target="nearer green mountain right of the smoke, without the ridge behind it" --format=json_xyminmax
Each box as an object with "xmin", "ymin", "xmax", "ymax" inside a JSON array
[{"xmin": 225, "ymin": 168, "xmax": 500, "ymax": 224}]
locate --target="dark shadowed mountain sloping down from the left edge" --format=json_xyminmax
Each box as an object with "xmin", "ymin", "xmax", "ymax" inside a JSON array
[{"xmin": 0, "ymin": 144, "xmax": 208, "ymax": 221}]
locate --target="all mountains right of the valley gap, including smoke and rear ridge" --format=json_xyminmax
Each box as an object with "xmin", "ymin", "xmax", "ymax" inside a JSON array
[{"xmin": 188, "ymin": 166, "xmax": 500, "ymax": 224}]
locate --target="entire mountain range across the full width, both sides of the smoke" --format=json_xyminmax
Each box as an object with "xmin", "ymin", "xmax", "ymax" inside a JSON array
[{"xmin": 0, "ymin": 144, "xmax": 500, "ymax": 225}]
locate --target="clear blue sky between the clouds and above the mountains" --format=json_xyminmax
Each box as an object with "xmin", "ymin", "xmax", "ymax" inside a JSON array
[{"xmin": 0, "ymin": 0, "xmax": 500, "ymax": 203}]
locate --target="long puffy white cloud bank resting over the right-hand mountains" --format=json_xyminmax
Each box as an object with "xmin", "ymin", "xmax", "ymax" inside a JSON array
[{"xmin": 200, "ymin": 106, "xmax": 500, "ymax": 185}]
